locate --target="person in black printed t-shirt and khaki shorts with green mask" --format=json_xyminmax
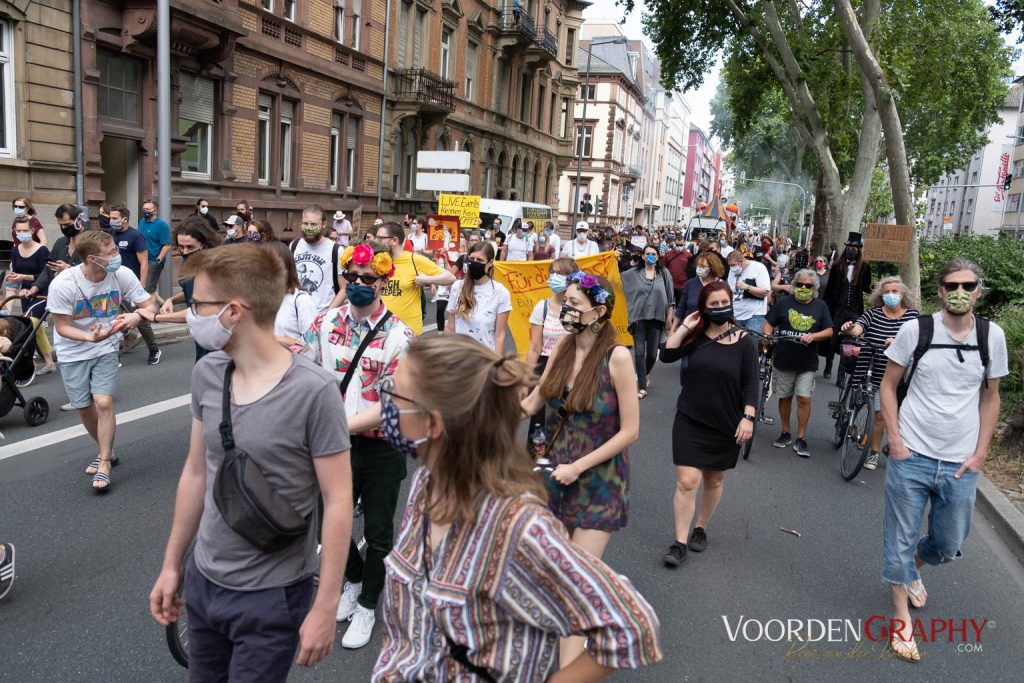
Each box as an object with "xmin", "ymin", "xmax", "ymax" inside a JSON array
[{"xmin": 764, "ymin": 268, "xmax": 833, "ymax": 458}]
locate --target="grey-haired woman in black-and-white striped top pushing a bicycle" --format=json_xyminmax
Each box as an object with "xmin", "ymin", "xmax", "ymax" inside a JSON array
[{"xmin": 842, "ymin": 275, "xmax": 921, "ymax": 470}]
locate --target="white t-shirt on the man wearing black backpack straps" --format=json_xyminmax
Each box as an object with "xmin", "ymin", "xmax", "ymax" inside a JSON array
[{"xmin": 886, "ymin": 311, "xmax": 1010, "ymax": 463}]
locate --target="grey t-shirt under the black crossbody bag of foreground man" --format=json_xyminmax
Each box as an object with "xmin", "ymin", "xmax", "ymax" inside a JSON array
[{"xmin": 191, "ymin": 351, "xmax": 349, "ymax": 591}]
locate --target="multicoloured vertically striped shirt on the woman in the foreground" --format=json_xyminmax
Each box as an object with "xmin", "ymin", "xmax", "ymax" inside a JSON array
[{"xmin": 373, "ymin": 467, "xmax": 662, "ymax": 683}]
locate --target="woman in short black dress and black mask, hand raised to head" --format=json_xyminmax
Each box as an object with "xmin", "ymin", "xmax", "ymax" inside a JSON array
[{"xmin": 662, "ymin": 282, "xmax": 759, "ymax": 566}]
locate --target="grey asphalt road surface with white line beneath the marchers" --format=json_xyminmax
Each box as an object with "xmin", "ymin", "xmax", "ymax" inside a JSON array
[{"xmin": 0, "ymin": 335, "xmax": 1024, "ymax": 683}]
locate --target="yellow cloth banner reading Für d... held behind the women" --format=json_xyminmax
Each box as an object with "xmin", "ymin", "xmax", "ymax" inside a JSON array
[{"xmin": 495, "ymin": 252, "xmax": 633, "ymax": 359}]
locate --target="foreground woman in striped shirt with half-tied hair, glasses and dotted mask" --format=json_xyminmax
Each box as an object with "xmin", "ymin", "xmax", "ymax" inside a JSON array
[{"xmin": 372, "ymin": 337, "xmax": 662, "ymax": 683}]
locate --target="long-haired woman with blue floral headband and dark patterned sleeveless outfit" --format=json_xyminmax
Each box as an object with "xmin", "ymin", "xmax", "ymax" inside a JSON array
[{"xmin": 522, "ymin": 271, "xmax": 640, "ymax": 665}]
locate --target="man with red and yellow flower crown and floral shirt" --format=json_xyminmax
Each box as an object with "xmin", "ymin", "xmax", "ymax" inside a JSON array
[{"xmin": 292, "ymin": 243, "xmax": 413, "ymax": 648}]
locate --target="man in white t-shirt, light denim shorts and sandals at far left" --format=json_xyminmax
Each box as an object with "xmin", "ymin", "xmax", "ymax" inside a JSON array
[{"xmin": 46, "ymin": 230, "xmax": 157, "ymax": 493}]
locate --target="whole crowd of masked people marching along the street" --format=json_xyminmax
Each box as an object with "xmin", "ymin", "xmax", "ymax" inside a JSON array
[{"xmin": 0, "ymin": 198, "xmax": 1008, "ymax": 681}]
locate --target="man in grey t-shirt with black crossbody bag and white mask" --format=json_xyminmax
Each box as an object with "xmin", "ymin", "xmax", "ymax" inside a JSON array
[{"xmin": 150, "ymin": 245, "xmax": 352, "ymax": 681}]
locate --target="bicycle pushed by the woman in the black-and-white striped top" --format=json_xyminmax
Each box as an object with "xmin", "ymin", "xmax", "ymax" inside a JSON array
[{"xmin": 828, "ymin": 337, "xmax": 885, "ymax": 481}]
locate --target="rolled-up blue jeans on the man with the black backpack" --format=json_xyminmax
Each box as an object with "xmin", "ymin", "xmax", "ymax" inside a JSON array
[{"xmin": 882, "ymin": 451, "xmax": 978, "ymax": 585}]
